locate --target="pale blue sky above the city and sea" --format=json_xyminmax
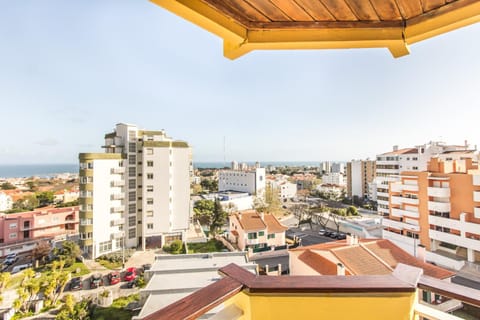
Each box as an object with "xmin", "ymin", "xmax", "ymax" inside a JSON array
[{"xmin": 0, "ymin": 0, "xmax": 480, "ymax": 165}]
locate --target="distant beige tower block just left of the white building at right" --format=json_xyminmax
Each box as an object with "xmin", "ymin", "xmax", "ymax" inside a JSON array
[{"xmin": 347, "ymin": 160, "xmax": 375, "ymax": 199}]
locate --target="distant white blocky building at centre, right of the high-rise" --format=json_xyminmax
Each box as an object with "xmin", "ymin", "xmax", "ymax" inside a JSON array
[{"xmin": 218, "ymin": 168, "xmax": 265, "ymax": 196}]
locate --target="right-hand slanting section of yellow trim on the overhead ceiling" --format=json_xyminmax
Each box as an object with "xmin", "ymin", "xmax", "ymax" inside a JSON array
[{"xmin": 405, "ymin": 1, "xmax": 480, "ymax": 44}]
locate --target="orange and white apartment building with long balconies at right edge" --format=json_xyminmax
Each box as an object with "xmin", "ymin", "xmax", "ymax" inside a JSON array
[{"xmin": 382, "ymin": 158, "xmax": 480, "ymax": 269}]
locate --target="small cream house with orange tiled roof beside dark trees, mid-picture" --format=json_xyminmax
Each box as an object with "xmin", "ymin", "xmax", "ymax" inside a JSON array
[{"xmin": 228, "ymin": 210, "xmax": 288, "ymax": 250}]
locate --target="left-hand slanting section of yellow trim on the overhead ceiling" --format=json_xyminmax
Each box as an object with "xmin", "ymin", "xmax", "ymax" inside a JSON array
[{"xmin": 150, "ymin": 0, "xmax": 247, "ymax": 43}]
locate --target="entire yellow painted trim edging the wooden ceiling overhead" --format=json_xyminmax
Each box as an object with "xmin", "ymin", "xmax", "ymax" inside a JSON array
[{"xmin": 150, "ymin": 0, "xmax": 480, "ymax": 59}]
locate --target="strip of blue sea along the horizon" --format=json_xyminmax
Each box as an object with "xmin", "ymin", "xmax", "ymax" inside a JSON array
[{"xmin": 0, "ymin": 161, "xmax": 320, "ymax": 178}]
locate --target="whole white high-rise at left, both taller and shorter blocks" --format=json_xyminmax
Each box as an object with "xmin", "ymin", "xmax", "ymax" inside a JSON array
[{"xmin": 80, "ymin": 123, "xmax": 193, "ymax": 256}]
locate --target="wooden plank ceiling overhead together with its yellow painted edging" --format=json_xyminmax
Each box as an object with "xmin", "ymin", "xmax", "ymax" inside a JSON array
[{"xmin": 151, "ymin": 0, "xmax": 480, "ymax": 59}]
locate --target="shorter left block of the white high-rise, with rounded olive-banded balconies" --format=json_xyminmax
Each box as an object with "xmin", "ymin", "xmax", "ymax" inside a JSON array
[{"xmin": 79, "ymin": 153, "xmax": 125, "ymax": 258}]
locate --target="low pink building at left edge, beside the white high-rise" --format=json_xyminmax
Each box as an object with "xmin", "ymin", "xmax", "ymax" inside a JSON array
[{"xmin": 0, "ymin": 206, "xmax": 79, "ymax": 256}]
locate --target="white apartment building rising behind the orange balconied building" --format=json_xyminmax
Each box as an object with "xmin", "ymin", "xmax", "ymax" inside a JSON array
[{"xmin": 375, "ymin": 141, "xmax": 476, "ymax": 216}]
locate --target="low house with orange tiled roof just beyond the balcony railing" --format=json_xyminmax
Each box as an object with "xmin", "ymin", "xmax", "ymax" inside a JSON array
[{"xmin": 289, "ymin": 237, "xmax": 462, "ymax": 311}]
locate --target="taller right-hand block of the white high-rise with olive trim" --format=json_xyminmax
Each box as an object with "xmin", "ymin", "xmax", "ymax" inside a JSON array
[{"xmin": 81, "ymin": 123, "xmax": 193, "ymax": 258}]
